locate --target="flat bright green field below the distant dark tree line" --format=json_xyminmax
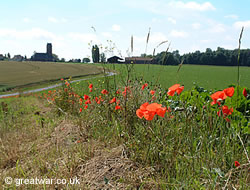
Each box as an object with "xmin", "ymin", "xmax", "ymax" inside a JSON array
[{"xmin": 103, "ymin": 64, "xmax": 250, "ymax": 89}]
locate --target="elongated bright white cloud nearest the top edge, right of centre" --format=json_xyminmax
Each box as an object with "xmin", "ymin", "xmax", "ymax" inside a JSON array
[{"xmin": 169, "ymin": 1, "xmax": 216, "ymax": 11}]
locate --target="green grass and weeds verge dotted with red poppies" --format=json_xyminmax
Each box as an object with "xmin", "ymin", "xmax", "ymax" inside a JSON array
[{"xmin": 36, "ymin": 77, "xmax": 250, "ymax": 189}]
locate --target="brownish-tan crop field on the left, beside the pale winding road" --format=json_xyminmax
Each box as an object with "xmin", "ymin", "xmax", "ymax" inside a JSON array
[{"xmin": 0, "ymin": 61, "xmax": 101, "ymax": 90}]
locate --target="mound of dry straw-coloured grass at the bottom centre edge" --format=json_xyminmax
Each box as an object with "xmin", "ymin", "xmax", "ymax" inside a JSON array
[{"xmin": 78, "ymin": 146, "xmax": 152, "ymax": 189}]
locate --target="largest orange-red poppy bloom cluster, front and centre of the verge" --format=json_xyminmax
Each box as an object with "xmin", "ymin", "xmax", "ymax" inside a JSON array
[{"xmin": 136, "ymin": 102, "xmax": 167, "ymax": 121}]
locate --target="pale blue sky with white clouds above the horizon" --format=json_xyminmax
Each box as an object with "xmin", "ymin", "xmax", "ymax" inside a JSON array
[{"xmin": 0, "ymin": 0, "xmax": 250, "ymax": 60}]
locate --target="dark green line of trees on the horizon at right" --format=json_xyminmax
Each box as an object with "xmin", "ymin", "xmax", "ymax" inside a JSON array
[{"xmin": 150, "ymin": 47, "xmax": 250, "ymax": 66}]
